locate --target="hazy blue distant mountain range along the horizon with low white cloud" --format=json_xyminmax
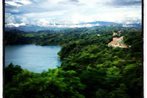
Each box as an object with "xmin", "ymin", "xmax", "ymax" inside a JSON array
[{"xmin": 5, "ymin": 21, "xmax": 142, "ymax": 32}]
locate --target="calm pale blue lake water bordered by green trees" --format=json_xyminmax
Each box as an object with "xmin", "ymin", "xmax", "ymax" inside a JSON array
[{"xmin": 5, "ymin": 45, "xmax": 61, "ymax": 72}]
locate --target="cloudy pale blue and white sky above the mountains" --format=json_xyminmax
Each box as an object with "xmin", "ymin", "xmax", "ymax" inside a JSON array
[{"xmin": 5, "ymin": 0, "xmax": 141, "ymax": 27}]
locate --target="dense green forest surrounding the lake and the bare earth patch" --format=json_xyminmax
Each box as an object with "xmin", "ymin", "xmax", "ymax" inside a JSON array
[{"xmin": 4, "ymin": 27, "xmax": 143, "ymax": 98}]
